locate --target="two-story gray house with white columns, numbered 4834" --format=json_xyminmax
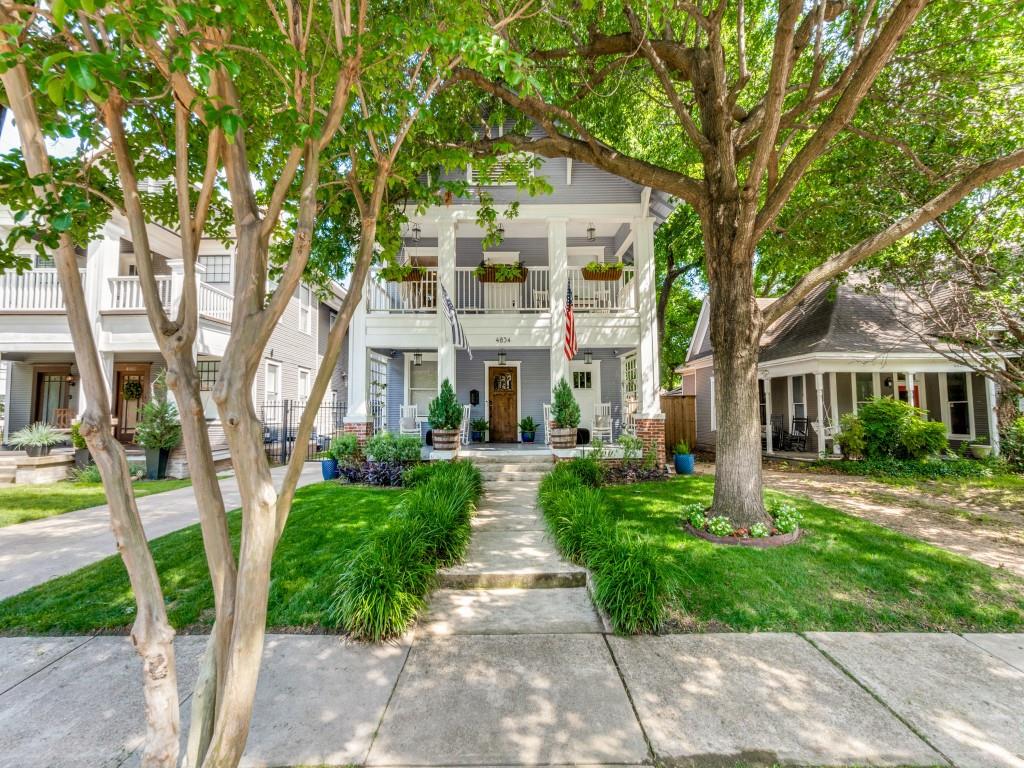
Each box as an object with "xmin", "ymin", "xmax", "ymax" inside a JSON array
[{"xmin": 346, "ymin": 159, "xmax": 671, "ymax": 456}]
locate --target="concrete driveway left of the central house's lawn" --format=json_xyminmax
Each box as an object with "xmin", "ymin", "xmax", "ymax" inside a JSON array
[{"xmin": 0, "ymin": 463, "xmax": 323, "ymax": 600}]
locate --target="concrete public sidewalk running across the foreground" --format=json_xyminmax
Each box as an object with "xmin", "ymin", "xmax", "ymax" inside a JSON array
[{"xmin": 0, "ymin": 633, "xmax": 1024, "ymax": 768}]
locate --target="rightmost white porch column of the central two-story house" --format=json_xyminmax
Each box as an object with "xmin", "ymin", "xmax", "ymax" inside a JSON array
[{"xmin": 633, "ymin": 216, "xmax": 662, "ymax": 416}]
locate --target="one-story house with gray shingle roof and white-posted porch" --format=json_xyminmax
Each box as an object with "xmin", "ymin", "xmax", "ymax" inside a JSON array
[{"xmin": 678, "ymin": 283, "xmax": 998, "ymax": 455}]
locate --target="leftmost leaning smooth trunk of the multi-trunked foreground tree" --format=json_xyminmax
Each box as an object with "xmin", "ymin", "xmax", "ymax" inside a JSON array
[{"xmin": 0, "ymin": 43, "xmax": 179, "ymax": 768}]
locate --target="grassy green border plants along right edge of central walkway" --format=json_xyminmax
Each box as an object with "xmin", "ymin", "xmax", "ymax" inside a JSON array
[{"xmin": 540, "ymin": 459, "xmax": 672, "ymax": 635}]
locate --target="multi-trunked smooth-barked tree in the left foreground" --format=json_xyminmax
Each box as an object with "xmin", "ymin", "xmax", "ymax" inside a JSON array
[{"xmin": 0, "ymin": 0, "xmax": 528, "ymax": 766}]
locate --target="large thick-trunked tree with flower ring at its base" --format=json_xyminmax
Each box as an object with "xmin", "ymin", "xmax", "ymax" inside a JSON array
[{"xmin": 445, "ymin": 0, "xmax": 1024, "ymax": 526}]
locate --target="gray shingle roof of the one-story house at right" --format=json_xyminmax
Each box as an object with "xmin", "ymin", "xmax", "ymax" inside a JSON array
[{"xmin": 686, "ymin": 280, "xmax": 934, "ymax": 372}]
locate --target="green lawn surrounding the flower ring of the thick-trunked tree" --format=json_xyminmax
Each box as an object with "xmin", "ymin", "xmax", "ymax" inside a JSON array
[{"xmin": 605, "ymin": 477, "xmax": 1024, "ymax": 632}]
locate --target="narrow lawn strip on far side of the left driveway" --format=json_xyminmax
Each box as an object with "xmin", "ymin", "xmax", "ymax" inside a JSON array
[{"xmin": 0, "ymin": 479, "xmax": 190, "ymax": 528}]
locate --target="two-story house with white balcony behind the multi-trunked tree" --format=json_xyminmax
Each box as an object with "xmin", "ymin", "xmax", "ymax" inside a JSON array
[{"xmin": 0, "ymin": 211, "xmax": 347, "ymax": 468}]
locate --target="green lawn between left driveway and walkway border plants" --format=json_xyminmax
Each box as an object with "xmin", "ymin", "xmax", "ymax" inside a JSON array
[{"xmin": 0, "ymin": 483, "xmax": 400, "ymax": 635}]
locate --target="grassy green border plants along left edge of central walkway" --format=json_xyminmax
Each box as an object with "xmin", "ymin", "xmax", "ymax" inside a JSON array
[{"xmin": 328, "ymin": 462, "xmax": 483, "ymax": 642}]
